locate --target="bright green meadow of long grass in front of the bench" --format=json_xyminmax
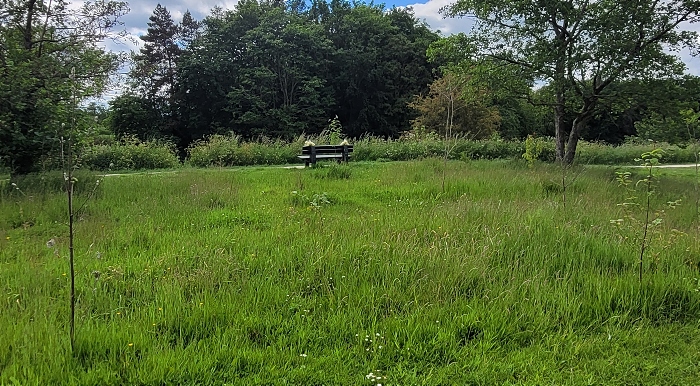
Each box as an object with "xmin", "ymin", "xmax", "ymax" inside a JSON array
[{"xmin": 0, "ymin": 160, "xmax": 700, "ymax": 385}]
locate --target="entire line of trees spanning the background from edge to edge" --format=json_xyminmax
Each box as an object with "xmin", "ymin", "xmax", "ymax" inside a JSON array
[{"xmin": 0, "ymin": 0, "xmax": 700, "ymax": 174}]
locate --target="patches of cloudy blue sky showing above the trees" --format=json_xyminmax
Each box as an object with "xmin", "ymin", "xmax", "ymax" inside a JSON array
[{"xmin": 97, "ymin": 0, "xmax": 700, "ymax": 99}]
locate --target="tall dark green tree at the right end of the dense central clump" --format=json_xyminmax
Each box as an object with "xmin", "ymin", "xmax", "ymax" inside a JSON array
[{"xmin": 309, "ymin": 0, "xmax": 438, "ymax": 137}]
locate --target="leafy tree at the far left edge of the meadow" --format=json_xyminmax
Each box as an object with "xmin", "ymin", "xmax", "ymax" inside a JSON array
[{"xmin": 0, "ymin": 0, "xmax": 128, "ymax": 175}]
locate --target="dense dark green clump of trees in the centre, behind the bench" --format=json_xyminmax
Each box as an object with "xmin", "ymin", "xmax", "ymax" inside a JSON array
[{"xmin": 110, "ymin": 0, "xmax": 439, "ymax": 154}]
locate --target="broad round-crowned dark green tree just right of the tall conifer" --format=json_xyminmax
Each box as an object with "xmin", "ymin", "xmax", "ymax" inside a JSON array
[{"xmin": 178, "ymin": 1, "xmax": 333, "ymax": 144}]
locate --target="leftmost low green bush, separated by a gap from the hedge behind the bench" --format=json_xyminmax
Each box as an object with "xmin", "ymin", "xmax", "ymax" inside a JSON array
[{"xmin": 82, "ymin": 140, "xmax": 179, "ymax": 171}]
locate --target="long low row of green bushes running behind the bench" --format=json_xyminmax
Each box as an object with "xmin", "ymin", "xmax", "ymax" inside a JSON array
[{"xmin": 39, "ymin": 135, "xmax": 699, "ymax": 170}]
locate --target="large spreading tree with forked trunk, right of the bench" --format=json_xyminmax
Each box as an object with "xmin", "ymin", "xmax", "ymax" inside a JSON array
[{"xmin": 444, "ymin": 0, "xmax": 700, "ymax": 164}]
